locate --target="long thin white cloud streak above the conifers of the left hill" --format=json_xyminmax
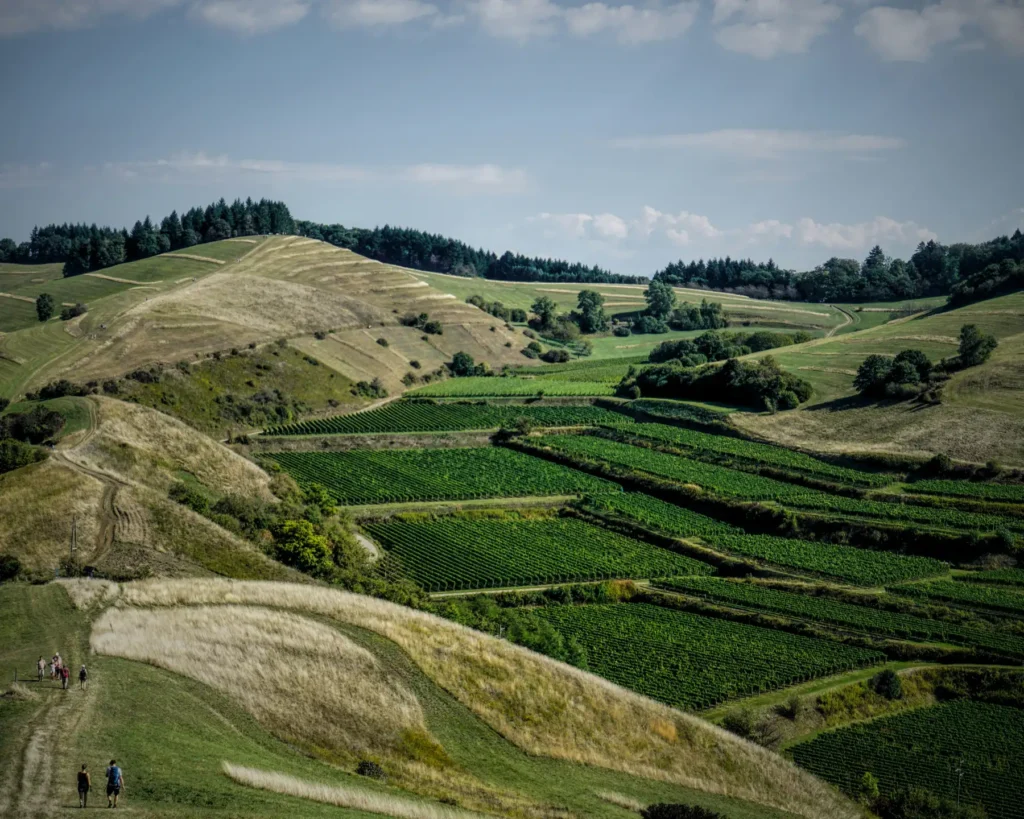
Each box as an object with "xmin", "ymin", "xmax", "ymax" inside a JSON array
[{"xmin": 102, "ymin": 153, "xmax": 528, "ymax": 193}]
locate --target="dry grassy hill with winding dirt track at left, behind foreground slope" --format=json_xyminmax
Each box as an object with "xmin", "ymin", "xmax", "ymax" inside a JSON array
[{"xmin": 0, "ymin": 396, "xmax": 299, "ymax": 578}]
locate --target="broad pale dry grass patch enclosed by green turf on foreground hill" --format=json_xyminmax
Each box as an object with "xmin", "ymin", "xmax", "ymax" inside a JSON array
[{"xmin": 90, "ymin": 606, "xmax": 425, "ymax": 760}]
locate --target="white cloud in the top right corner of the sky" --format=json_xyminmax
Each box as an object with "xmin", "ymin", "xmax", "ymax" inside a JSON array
[{"xmin": 854, "ymin": 0, "xmax": 1024, "ymax": 62}]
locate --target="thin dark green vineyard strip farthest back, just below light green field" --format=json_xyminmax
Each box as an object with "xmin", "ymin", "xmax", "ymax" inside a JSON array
[{"xmin": 265, "ymin": 401, "xmax": 630, "ymax": 435}]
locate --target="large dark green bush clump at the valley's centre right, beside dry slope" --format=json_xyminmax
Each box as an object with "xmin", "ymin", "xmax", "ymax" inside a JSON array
[{"xmin": 620, "ymin": 356, "xmax": 813, "ymax": 410}]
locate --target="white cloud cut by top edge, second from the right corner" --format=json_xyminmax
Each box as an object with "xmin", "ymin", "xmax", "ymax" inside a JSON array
[{"xmin": 713, "ymin": 0, "xmax": 843, "ymax": 59}]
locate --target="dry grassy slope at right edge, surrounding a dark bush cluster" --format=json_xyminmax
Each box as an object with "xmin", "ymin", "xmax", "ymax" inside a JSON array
[{"xmin": 732, "ymin": 293, "xmax": 1024, "ymax": 465}]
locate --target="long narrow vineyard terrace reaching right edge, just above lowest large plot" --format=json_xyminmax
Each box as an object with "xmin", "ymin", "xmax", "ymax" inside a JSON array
[{"xmin": 658, "ymin": 577, "xmax": 1024, "ymax": 657}]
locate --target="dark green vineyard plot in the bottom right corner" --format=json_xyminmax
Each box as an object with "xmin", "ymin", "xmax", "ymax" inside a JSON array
[{"xmin": 792, "ymin": 700, "xmax": 1024, "ymax": 819}]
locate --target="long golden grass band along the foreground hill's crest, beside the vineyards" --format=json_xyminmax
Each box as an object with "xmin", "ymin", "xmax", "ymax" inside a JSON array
[{"xmin": 112, "ymin": 580, "xmax": 858, "ymax": 819}]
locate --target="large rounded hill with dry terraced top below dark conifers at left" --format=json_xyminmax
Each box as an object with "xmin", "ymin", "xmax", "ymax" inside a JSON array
[{"xmin": 0, "ymin": 236, "xmax": 524, "ymax": 397}]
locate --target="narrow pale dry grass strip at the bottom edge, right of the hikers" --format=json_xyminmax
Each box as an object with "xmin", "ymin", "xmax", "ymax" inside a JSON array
[{"xmin": 223, "ymin": 762, "xmax": 482, "ymax": 819}]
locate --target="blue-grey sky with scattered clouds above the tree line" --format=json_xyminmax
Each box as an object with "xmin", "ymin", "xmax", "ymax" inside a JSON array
[{"xmin": 0, "ymin": 0, "xmax": 1024, "ymax": 274}]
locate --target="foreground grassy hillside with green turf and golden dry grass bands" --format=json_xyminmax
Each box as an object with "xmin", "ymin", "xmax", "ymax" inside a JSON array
[{"xmin": 0, "ymin": 581, "xmax": 858, "ymax": 819}]
